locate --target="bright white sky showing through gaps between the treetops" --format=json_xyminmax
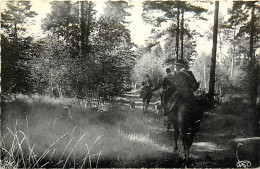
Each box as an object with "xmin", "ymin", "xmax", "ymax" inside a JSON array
[{"xmin": 1, "ymin": 0, "xmax": 235, "ymax": 54}]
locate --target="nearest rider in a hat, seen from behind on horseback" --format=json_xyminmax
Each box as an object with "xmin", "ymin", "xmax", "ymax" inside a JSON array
[{"xmin": 165, "ymin": 59, "xmax": 200, "ymax": 117}]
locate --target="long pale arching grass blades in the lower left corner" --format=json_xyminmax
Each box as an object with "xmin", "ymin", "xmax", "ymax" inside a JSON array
[{"xmin": 0, "ymin": 123, "xmax": 104, "ymax": 168}]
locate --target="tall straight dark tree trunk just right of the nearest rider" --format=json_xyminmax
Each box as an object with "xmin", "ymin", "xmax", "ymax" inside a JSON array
[{"xmin": 209, "ymin": 1, "xmax": 219, "ymax": 99}]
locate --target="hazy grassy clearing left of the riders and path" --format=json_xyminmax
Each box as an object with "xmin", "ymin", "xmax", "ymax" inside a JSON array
[{"xmin": 2, "ymin": 96, "xmax": 176, "ymax": 168}]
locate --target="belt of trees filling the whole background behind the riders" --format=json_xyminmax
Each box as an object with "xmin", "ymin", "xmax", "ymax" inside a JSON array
[{"xmin": 1, "ymin": 1, "xmax": 260, "ymax": 167}]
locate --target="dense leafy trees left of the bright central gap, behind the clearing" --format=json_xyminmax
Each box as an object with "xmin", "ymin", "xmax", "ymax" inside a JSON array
[{"xmin": 2, "ymin": 1, "xmax": 135, "ymax": 101}]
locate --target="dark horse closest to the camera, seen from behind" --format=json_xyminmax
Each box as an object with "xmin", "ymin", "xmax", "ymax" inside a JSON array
[{"xmin": 166, "ymin": 94, "xmax": 213, "ymax": 164}]
